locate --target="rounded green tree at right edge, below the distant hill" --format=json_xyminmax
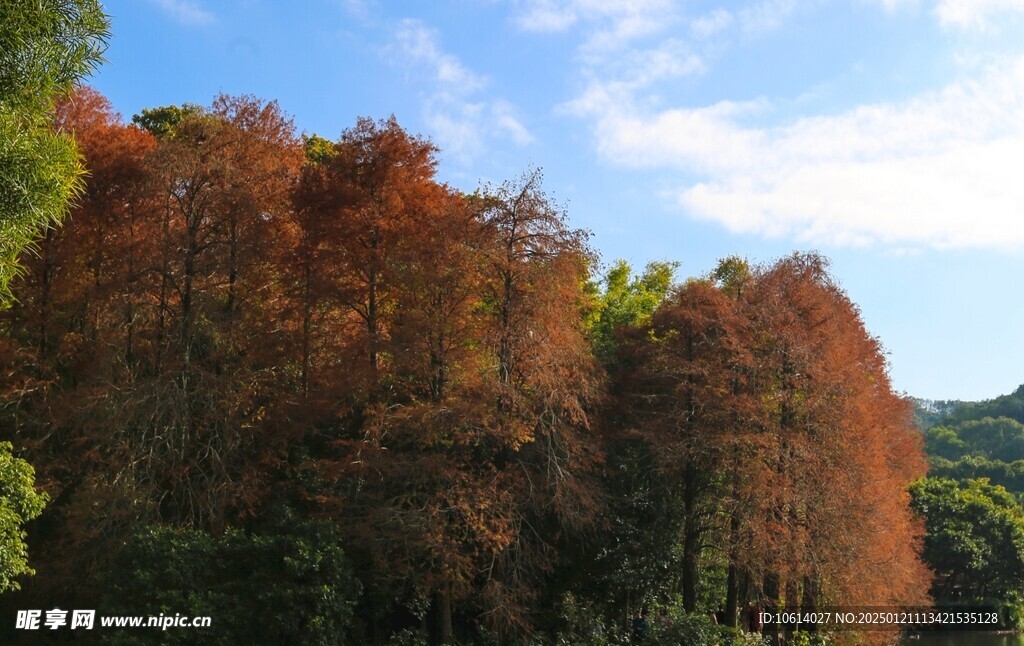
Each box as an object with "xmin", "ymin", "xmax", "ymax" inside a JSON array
[{"xmin": 910, "ymin": 477, "xmax": 1024, "ymax": 601}]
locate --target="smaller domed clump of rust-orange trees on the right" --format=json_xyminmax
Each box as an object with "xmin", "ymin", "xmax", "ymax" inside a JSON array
[{"xmin": 620, "ymin": 254, "xmax": 927, "ymax": 630}]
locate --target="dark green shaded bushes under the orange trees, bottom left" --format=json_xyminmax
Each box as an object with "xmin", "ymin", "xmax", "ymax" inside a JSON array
[{"xmin": 103, "ymin": 519, "xmax": 361, "ymax": 646}]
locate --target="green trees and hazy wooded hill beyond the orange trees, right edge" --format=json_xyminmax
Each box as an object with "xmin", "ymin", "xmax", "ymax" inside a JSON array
[{"xmin": 910, "ymin": 386, "xmax": 1024, "ymax": 626}]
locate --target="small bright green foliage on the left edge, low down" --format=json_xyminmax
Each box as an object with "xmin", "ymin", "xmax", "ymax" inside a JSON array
[{"xmin": 0, "ymin": 442, "xmax": 47, "ymax": 593}]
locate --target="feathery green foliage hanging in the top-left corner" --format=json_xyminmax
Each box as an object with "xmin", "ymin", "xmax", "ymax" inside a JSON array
[{"xmin": 0, "ymin": 0, "xmax": 109, "ymax": 306}]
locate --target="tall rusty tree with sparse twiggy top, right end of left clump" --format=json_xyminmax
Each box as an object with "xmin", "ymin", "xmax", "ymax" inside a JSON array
[{"xmin": 473, "ymin": 169, "xmax": 602, "ymax": 638}]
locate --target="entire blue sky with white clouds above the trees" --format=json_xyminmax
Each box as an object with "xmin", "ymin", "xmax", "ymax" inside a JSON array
[{"xmin": 91, "ymin": 0, "xmax": 1024, "ymax": 399}]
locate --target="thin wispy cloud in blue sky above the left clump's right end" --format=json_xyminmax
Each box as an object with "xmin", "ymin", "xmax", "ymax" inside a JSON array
[{"xmin": 391, "ymin": 19, "xmax": 534, "ymax": 164}]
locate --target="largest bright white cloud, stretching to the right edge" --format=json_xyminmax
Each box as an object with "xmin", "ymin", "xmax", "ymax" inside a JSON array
[{"xmin": 571, "ymin": 59, "xmax": 1024, "ymax": 248}]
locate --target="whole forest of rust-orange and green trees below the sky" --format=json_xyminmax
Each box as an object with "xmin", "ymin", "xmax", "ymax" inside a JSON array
[{"xmin": 0, "ymin": 87, "xmax": 942, "ymax": 644}]
